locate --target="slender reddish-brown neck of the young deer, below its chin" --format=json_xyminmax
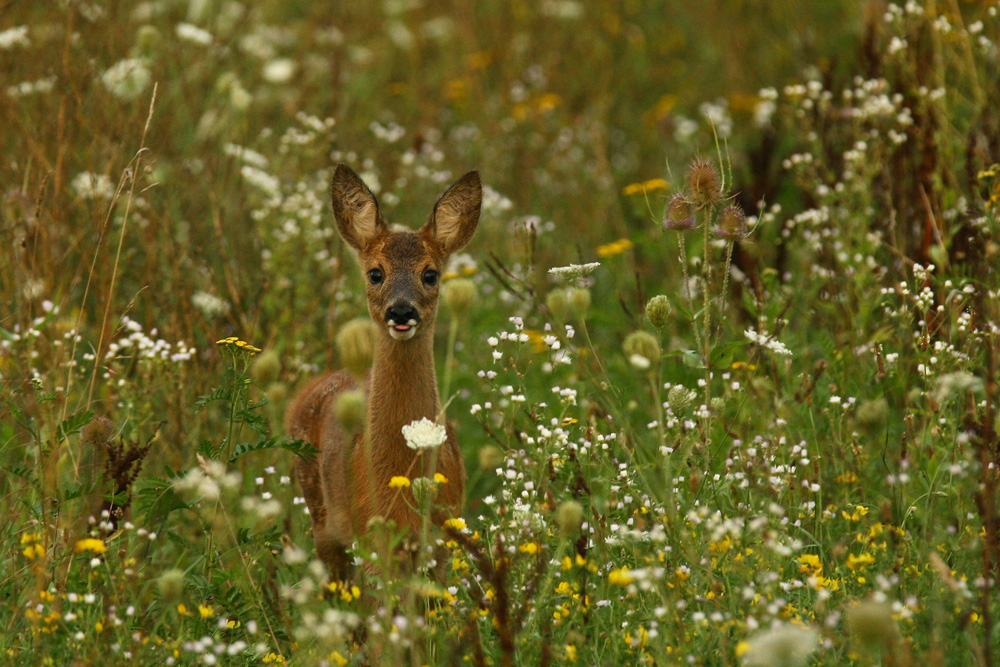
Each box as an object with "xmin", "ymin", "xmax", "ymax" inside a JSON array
[{"xmin": 368, "ymin": 327, "xmax": 441, "ymax": 462}]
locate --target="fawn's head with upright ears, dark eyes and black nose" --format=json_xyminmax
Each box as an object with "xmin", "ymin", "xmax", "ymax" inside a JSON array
[{"xmin": 333, "ymin": 164, "xmax": 482, "ymax": 341}]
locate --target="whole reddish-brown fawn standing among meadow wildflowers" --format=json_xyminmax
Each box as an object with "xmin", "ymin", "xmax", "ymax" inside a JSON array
[{"xmin": 285, "ymin": 164, "xmax": 482, "ymax": 579}]
